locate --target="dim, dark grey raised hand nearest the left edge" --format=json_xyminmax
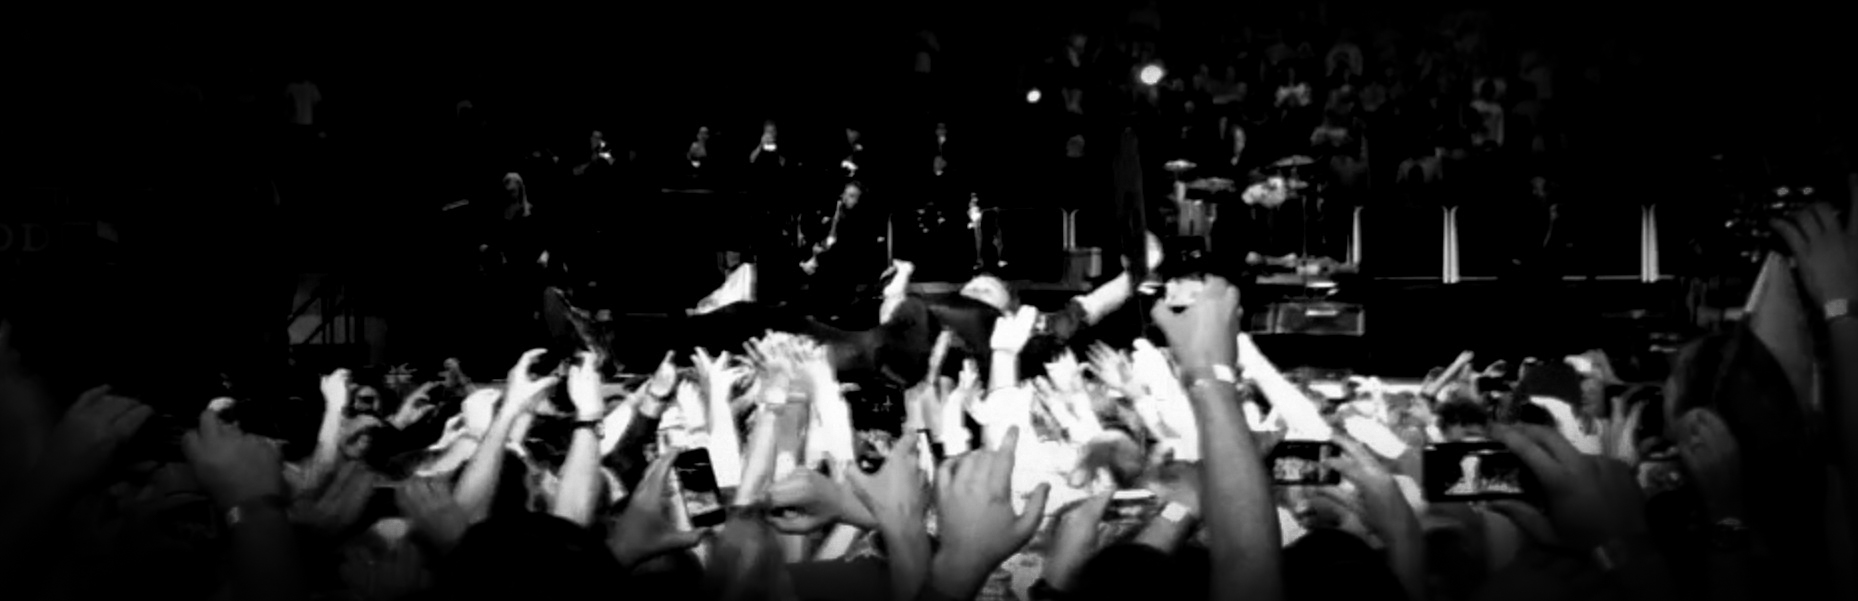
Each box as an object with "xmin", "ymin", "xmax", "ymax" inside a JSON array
[{"xmin": 39, "ymin": 385, "xmax": 154, "ymax": 484}]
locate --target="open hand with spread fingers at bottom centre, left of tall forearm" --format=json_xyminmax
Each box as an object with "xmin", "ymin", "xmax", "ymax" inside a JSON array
[{"xmin": 933, "ymin": 426, "xmax": 1052, "ymax": 599}]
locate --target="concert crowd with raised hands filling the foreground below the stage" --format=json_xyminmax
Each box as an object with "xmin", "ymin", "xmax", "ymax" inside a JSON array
[{"xmin": 0, "ymin": 200, "xmax": 1858, "ymax": 599}]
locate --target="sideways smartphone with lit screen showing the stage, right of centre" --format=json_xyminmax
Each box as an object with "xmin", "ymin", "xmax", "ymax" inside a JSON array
[{"xmin": 1425, "ymin": 441, "xmax": 1542, "ymax": 502}]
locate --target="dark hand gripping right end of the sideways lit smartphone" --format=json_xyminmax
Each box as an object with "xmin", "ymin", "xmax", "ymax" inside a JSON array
[{"xmin": 1492, "ymin": 426, "xmax": 1648, "ymax": 549}]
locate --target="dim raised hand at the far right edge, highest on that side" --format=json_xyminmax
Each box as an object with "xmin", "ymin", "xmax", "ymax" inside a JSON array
[{"xmin": 1773, "ymin": 203, "xmax": 1858, "ymax": 303}]
